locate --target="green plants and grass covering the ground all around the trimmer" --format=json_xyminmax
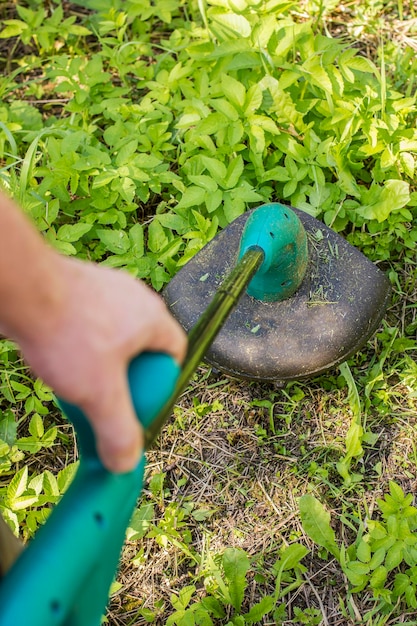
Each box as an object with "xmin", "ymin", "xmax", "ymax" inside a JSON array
[{"xmin": 0, "ymin": 0, "xmax": 417, "ymax": 626}]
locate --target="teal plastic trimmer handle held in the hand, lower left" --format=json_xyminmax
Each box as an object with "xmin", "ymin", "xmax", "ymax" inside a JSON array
[{"xmin": 0, "ymin": 353, "xmax": 180, "ymax": 626}]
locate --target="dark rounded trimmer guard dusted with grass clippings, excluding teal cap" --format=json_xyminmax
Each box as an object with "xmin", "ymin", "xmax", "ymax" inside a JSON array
[{"xmin": 164, "ymin": 204, "xmax": 390, "ymax": 381}]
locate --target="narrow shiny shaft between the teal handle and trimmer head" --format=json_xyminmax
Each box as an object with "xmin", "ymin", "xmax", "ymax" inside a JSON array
[{"xmin": 145, "ymin": 247, "xmax": 265, "ymax": 449}]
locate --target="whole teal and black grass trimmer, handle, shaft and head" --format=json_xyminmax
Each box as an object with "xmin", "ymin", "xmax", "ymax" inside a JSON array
[{"xmin": 0, "ymin": 204, "xmax": 389, "ymax": 626}]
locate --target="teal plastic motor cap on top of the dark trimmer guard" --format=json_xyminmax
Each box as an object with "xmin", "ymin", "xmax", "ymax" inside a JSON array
[{"xmin": 239, "ymin": 202, "xmax": 308, "ymax": 302}]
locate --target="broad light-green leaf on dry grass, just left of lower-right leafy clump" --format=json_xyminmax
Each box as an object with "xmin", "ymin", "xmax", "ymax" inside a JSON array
[{"xmin": 299, "ymin": 494, "xmax": 339, "ymax": 559}]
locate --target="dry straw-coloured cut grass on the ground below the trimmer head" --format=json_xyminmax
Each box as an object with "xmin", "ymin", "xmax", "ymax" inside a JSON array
[{"xmin": 103, "ymin": 344, "xmax": 417, "ymax": 626}]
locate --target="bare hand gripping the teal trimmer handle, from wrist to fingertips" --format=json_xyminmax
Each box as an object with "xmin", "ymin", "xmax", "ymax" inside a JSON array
[{"xmin": 21, "ymin": 257, "xmax": 186, "ymax": 472}]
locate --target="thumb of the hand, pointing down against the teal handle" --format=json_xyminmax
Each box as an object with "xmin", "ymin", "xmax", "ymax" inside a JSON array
[{"xmin": 86, "ymin": 372, "xmax": 143, "ymax": 473}]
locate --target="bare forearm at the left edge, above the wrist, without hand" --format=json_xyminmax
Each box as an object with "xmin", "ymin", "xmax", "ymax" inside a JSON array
[{"xmin": 0, "ymin": 194, "xmax": 61, "ymax": 341}]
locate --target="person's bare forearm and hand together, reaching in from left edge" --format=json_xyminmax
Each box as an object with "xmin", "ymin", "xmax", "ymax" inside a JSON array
[{"xmin": 0, "ymin": 195, "xmax": 186, "ymax": 472}]
